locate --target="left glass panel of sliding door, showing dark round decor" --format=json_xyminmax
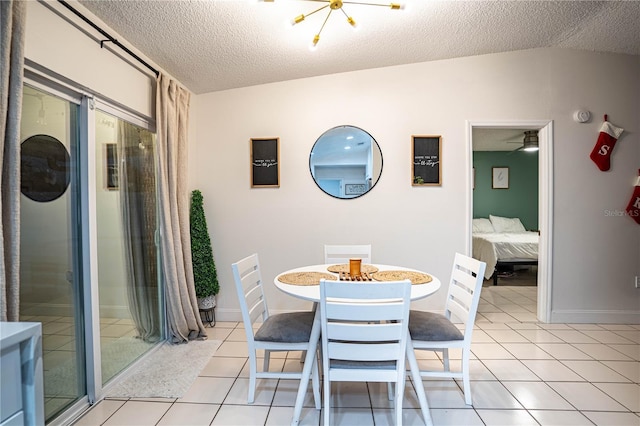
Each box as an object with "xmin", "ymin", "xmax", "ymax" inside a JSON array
[{"xmin": 20, "ymin": 87, "xmax": 87, "ymax": 419}]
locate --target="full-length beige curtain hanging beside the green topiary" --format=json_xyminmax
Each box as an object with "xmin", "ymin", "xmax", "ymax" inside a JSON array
[{"xmin": 156, "ymin": 74, "xmax": 206, "ymax": 343}]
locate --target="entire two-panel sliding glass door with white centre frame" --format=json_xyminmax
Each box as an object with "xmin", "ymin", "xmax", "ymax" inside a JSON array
[{"xmin": 20, "ymin": 80, "xmax": 164, "ymax": 422}]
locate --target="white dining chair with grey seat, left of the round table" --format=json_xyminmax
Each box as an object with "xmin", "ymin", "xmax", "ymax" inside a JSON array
[{"xmin": 231, "ymin": 254, "xmax": 320, "ymax": 410}]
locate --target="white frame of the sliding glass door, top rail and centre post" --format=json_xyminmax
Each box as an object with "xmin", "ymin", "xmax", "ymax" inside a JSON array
[{"xmin": 24, "ymin": 65, "xmax": 166, "ymax": 425}]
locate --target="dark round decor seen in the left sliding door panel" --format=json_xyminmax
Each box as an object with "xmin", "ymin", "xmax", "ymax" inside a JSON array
[{"xmin": 20, "ymin": 135, "xmax": 70, "ymax": 202}]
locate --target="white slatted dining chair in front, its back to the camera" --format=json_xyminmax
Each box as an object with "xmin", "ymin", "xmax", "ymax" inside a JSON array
[{"xmin": 320, "ymin": 280, "xmax": 411, "ymax": 426}]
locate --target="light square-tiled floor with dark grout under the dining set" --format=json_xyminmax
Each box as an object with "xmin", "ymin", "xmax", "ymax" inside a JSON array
[{"xmin": 75, "ymin": 286, "xmax": 640, "ymax": 426}]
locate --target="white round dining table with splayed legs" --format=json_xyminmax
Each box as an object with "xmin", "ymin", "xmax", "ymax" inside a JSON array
[{"xmin": 273, "ymin": 264, "xmax": 441, "ymax": 425}]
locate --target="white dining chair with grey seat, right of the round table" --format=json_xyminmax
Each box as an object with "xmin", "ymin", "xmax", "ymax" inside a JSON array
[{"xmin": 409, "ymin": 253, "xmax": 487, "ymax": 405}]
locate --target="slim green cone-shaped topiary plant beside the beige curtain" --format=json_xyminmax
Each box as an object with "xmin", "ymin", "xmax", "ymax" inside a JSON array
[{"xmin": 189, "ymin": 189, "xmax": 220, "ymax": 299}]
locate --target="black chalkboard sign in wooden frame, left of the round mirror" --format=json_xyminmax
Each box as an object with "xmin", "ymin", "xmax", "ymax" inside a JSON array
[{"xmin": 250, "ymin": 138, "xmax": 280, "ymax": 188}]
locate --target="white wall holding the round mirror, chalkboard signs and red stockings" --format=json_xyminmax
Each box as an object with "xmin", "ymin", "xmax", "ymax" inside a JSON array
[{"xmin": 190, "ymin": 49, "xmax": 640, "ymax": 322}]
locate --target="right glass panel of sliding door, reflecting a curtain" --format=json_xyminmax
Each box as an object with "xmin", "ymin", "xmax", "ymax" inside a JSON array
[{"xmin": 95, "ymin": 110, "xmax": 162, "ymax": 385}]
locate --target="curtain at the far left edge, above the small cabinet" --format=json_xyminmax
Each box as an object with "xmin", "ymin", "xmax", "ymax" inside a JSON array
[{"xmin": 0, "ymin": 0, "xmax": 27, "ymax": 321}]
